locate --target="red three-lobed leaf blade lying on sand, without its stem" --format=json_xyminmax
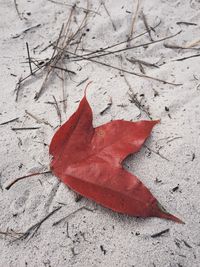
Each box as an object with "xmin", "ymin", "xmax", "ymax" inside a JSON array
[{"xmin": 49, "ymin": 85, "xmax": 182, "ymax": 223}]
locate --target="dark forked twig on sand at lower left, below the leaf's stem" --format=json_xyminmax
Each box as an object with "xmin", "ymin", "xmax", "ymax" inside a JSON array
[{"xmin": 14, "ymin": 207, "xmax": 62, "ymax": 241}]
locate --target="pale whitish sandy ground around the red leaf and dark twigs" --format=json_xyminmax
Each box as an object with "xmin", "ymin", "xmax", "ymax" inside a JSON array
[{"xmin": 0, "ymin": 0, "xmax": 200, "ymax": 267}]
